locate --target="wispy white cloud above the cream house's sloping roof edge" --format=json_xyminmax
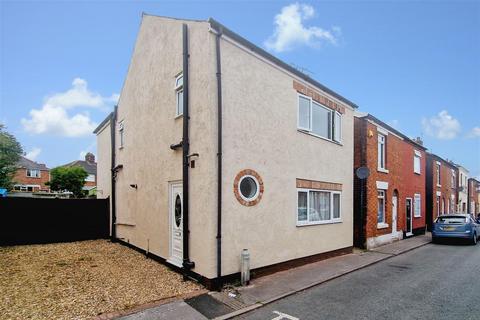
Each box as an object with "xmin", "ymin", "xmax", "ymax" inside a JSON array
[{"xmin": 264, "ymin": 2, "xmax": 341, "ymax": 52}]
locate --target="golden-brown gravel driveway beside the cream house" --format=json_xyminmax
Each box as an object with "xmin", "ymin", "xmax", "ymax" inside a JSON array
[{"xmin": 0, "ymin": 240, "xmax": 202, "ymax": 320}]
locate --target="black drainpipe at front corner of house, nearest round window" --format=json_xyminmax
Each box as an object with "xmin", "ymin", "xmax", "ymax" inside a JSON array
[{"xmin": 215, "ymin": 31, "xmax": 222, "ymax": 291}]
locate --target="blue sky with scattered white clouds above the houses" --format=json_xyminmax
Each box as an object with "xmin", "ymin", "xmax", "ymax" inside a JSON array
[{"xmin": 0, "ymin": 0, "xmax": 480, "ymax": 178}]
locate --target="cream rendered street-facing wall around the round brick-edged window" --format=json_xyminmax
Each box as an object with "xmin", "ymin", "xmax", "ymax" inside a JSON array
[{"xmin": 221, "ymin": 40, "xmax": 353, "ymax": 274}]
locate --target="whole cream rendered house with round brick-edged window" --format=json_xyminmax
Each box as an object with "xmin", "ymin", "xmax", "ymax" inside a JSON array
[{"xmin": 95, "ymin": 15, "xmax": 356, "ymax": 286}]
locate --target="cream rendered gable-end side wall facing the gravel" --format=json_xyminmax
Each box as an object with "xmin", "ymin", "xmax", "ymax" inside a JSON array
[{"xmin": 112, "ymin": 15, "xmax": 216, "ymax": 278}]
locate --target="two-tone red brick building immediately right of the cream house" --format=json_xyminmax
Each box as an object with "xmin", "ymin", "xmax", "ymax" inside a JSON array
[{"xmin": 354, "ymin": 113, "xmax": 426, "ymax": 248}]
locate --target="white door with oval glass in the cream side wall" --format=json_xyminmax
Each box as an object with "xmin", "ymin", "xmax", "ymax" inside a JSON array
[{"xmin": 168, "ymin": 183, "xmax": 183, "ymax": 267}]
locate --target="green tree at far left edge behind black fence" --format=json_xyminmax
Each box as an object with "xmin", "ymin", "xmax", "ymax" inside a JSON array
[{"xmin": 0, "ymin": 123, "xmax": 23, "ymax": 190}]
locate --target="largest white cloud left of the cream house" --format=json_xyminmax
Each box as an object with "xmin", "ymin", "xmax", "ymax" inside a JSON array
[{"xmin": 21, "ymin": 78, "xmax": 118, "ymax": 137}]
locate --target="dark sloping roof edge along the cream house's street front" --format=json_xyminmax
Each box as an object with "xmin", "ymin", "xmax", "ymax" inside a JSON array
[{"xmin": 207, "ymin": 18, "xmax": 358, "ymax": 109}]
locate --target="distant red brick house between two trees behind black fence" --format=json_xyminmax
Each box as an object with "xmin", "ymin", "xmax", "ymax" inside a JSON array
[{"xmin": 13, "ymin": 157, "xmax": 50, "ymax": 192}]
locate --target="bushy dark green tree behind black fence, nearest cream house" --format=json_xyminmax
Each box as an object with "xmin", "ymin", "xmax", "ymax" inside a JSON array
[{"xmin": 46, "ymin": 167, "xmax": 88, "ymax": 198}]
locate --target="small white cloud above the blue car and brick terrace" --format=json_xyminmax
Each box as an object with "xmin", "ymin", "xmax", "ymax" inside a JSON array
[{"xmin": 422, "ymin": 110, "xmax": 461, "ymax": 140}]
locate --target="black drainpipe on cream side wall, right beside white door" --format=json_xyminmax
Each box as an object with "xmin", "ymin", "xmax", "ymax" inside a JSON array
[{"xmin": 182, "ymin": 24, "xmax": 195, "ymax": 276}]
